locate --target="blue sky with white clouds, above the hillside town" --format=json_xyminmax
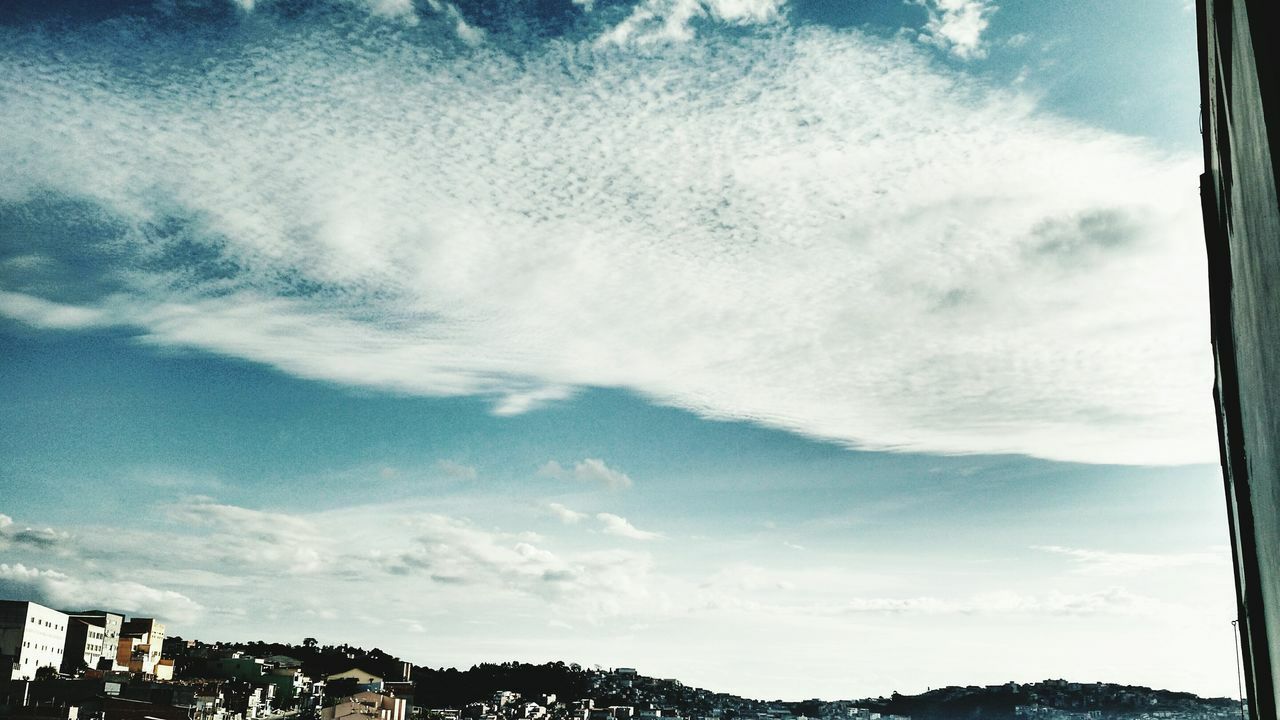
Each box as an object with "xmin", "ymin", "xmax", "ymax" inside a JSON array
[{"xmin": 0, "ymin": 0, "xmax": 1236, "ymax": 700}]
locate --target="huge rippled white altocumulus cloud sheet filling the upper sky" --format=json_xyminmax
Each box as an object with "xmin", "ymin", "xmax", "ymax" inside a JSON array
[{"xmin": 0, "ymin": 3, "xmax": 1216, "ymax": 462}]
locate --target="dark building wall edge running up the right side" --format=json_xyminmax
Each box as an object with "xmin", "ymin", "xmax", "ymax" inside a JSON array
[{"xmin": 1196, "ymin": 0, "xmax": 1280, "ymax": 720}]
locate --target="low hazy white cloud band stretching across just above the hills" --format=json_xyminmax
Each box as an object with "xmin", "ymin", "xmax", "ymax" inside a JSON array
[{"xmin": 0, "ymin": 497, "xmax": 1235, "ymax": 694}]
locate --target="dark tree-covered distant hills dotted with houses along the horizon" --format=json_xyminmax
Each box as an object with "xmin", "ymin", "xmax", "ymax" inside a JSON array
[{"xmin": 197, "ymin": 642, "xmax": 1240, "ymax": 720}]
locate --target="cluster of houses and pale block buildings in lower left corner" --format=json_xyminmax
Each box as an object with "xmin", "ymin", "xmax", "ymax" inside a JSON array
[{"xmin": 0, "ymin": 600, "xmax": 413, "ymax": 720}]
